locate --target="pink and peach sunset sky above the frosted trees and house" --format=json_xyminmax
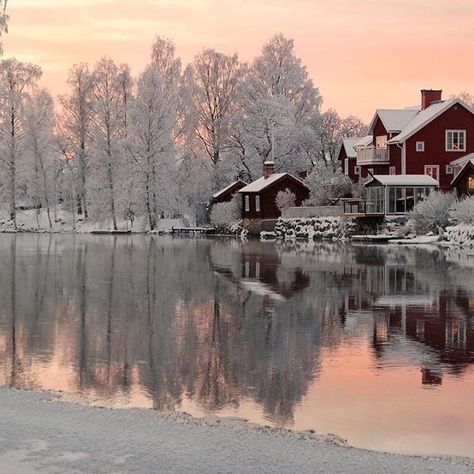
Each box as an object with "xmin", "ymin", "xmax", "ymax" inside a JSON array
[{"xmin": 4, "ymin": 0, "xmax": 474, "ymax": 121}]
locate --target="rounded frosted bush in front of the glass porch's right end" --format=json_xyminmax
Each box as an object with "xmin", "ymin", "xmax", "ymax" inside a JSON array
[{"xmin": 409, "ymin": 191, "xmax": 456, "ymax": 234}]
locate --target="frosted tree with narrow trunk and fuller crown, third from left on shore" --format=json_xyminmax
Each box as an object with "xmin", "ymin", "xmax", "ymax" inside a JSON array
[{"xmin": 57, "ymin": 64, "xmax": 94, "ymax": 218}]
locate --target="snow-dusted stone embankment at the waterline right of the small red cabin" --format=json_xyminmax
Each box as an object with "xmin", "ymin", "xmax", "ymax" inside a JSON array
[{"xmin": 274, "ymin": 217, "xmax": 356, "ymax": 240}]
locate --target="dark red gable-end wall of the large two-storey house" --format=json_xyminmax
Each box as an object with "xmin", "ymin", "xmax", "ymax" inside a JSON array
[{"xmin": 406, "ymin": 104, "xmax": 474, "ymax": 190}]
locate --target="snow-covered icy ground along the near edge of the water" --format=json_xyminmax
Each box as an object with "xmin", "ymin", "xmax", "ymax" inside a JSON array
[{"xmin": 0, "ymin": 389, "xmax": 474, "ymax": 474}]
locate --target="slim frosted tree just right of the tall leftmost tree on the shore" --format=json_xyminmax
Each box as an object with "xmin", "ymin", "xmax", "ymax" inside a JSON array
[{"xmin": 24, "ymin": 89, "xmax": 57, "ymax": 230}]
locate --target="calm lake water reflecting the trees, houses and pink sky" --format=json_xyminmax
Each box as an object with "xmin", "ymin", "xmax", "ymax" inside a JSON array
[{"xmin": 0, "ymin": 235, "xmax": 474, "ymax": 456}]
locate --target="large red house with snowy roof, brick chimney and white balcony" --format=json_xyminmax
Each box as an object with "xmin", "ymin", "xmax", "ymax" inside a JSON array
[{"xmin": 346, "ymin": 90, "xmax": 474, "ymax": 190}]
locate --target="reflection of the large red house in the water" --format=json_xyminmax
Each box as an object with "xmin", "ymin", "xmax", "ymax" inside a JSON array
[{"xmin": 345, "ymin": 248, "xmax": 474, "ymax": 385}]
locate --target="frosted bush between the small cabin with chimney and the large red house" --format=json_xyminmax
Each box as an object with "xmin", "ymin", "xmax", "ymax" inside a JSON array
[{"xmin": 305, "ymin": 163, "xmax": 352, "ymax": 206}]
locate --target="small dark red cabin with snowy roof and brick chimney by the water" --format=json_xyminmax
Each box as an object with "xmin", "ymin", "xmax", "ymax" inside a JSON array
[{"xmin": 239, "ymin": 161, "xmax": 309, "ymax": 219}]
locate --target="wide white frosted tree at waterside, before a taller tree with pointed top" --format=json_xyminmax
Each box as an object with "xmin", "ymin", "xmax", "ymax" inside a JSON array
[{"xmin": 128, "ymin": 65, "xmax": 175, "ymax": 230}]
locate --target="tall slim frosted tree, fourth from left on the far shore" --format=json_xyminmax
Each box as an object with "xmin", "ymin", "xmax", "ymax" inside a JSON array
[{"xmin": 91, "ymin": 58, "xmax": 127, "ymax": 230}]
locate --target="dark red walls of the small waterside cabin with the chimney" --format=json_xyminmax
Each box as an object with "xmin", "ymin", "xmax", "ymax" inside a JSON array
[{"xmin": 242, "ymin": 176, "xmax": 309, "ymax": 219}]
